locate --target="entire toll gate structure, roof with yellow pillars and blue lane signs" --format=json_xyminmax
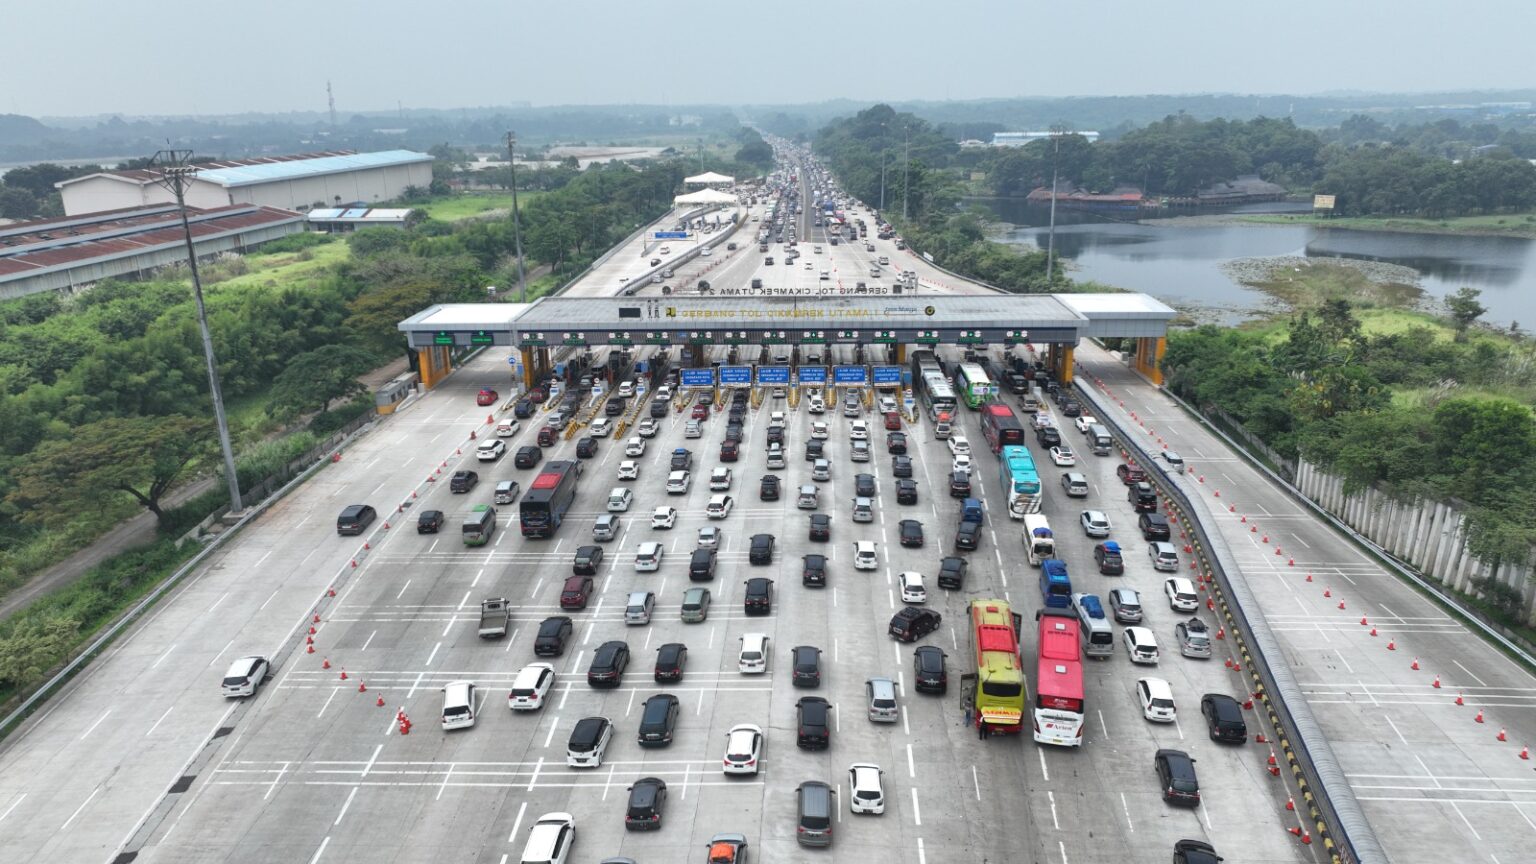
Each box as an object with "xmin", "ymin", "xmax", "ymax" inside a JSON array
[{"xmin": 399, "ymin": 294, "xmax": 1177, "ymax": 387}]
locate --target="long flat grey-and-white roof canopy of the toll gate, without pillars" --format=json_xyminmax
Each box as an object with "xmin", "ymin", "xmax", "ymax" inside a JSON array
[{"xmin": 399, "ymin": 294, "xmax": 1175, "ymax": 349}]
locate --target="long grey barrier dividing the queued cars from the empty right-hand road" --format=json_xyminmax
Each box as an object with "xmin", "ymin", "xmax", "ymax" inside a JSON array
[{"xmin": 1075, "ymin": 380, "xmax": 1390, "ymax": 864}]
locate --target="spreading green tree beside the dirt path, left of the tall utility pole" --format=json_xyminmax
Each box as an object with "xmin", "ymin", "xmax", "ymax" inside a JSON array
[{"xmin": 6, "ymin": 415, "xmax": 214, "ymax": 527}]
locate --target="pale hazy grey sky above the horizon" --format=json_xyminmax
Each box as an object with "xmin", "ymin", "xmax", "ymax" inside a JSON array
[{"xmin": 0, "ymin": 0, "xmax": 1536, "ymax": 115}]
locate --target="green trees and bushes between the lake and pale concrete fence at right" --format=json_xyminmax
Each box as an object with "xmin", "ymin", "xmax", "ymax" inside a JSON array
[{"xmin": 1164, "ymin": 301, "xmax": 1536, "ymax": 561}]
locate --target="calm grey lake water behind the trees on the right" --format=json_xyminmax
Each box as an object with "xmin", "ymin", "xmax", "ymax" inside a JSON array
[{"xmin": 972, "ymin": 200, "xmax": 1536, "ymax": 329}]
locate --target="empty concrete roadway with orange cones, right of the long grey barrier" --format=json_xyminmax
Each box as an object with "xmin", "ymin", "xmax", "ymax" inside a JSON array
[{"xmin": 1077, "ymin": 343, "xmax": 1536, "ymax": 864}]
